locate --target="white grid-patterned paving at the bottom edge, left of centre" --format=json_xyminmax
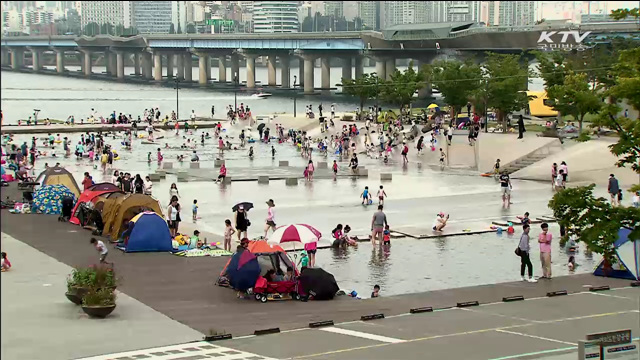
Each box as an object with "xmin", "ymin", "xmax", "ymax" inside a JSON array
[{"xmin": 79, "ymin": 341, "xmax": 274, "ymax": 360}]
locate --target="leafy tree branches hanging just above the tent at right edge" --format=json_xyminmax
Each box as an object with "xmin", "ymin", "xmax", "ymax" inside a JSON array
[{"xmin": 549, "ymin": 184, "xmax": 640, "ymax": 264}]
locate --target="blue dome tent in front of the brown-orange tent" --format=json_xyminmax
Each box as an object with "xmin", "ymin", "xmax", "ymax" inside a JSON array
[{"xmin": 119, "ymin": 211, "xmax": 173, "ymax": 252}]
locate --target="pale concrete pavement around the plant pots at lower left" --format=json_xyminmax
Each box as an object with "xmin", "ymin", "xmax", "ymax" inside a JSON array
[{"xmin": 1, "ymin": 232, "xmax": 202, "ymax": 360}]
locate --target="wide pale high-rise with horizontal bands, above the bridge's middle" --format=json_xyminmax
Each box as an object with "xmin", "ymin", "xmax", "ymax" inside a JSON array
[{"xmin": 253, "ymin": 1, "xmax": 299, "ymax": 33}]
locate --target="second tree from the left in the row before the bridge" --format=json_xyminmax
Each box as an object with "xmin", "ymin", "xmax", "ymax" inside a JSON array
[{"xmin": 382, "ymin": 61, "xmax": 425, "ymax": 116}]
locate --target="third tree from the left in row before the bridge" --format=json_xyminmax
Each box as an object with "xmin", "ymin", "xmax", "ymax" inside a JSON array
[{"xmin": 425, "ymin": 61, "xmax": 482, "ymax": 119}]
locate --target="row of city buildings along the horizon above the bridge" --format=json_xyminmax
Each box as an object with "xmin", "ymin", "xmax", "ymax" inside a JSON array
[{"xmin": 2, "ymin": 1, "xmax": 638, "ymax": 35}]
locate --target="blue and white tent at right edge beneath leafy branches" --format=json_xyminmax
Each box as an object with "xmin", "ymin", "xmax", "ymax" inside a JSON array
[{"xmin": 593, "ymin": 228, "xmax": 640, "ymax": 280}]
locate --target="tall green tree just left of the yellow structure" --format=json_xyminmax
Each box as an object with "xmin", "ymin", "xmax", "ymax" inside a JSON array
[{"xmin": 483, "ymin": 53, "xmax": 532, "ymax": 133}]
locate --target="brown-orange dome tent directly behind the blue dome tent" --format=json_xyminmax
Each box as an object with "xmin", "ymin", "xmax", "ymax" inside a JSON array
[{"xmin": 102, "ymin": 194, "xmax": 163, "ymax": 240}]
